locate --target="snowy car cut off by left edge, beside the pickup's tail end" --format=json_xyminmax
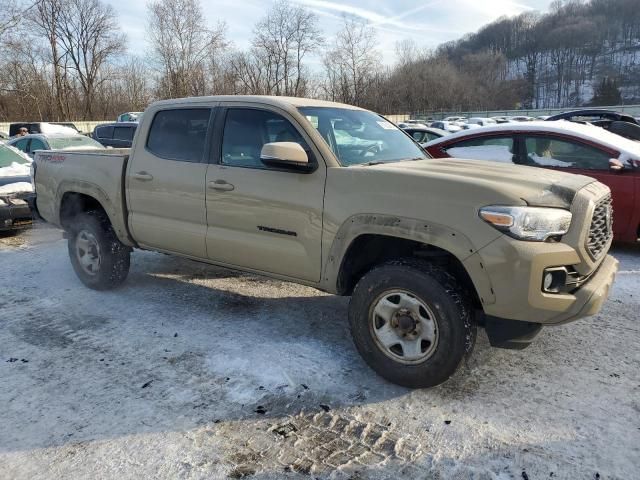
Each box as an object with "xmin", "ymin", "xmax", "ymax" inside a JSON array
[{"xmin": 0, "ymin": 144, "xmax": 33, "ymax": 234}]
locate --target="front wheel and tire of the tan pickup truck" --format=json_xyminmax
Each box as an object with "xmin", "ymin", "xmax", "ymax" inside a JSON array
[{"xmin": 349, "ymin": 259, "xmax": 476, "ymax": 388}]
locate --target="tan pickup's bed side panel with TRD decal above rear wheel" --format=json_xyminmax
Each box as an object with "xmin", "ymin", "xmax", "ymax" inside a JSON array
[{"xmin": 34, "ymin": 148, "xmax": 130, "ymax": 241}]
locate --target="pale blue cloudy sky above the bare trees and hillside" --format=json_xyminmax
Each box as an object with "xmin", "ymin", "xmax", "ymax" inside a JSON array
[{"xmin": 106, "ymin": 0, "xmax": 551, "ymax": 64}]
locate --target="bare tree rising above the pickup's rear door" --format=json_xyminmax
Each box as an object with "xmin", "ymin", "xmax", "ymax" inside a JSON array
[{"xmin": 148, "ymin": 0, "xmax": 226, "ymax": 97}]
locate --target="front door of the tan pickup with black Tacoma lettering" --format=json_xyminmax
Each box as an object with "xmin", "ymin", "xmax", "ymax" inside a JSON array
[{"xmin": 207, "ymin": 106, "xmax": 326, "ymax": 282}]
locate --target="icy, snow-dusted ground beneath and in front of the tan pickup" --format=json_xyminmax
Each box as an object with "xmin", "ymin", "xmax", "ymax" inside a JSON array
[{"xmin": 0, "ymin": 227, "xmax": 640, "ymax": 480}]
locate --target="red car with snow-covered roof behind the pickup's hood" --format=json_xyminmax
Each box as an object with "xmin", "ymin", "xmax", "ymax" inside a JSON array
[{"xmin": 426, "ymin": 121, "xmax": 640, "ymax": 243}]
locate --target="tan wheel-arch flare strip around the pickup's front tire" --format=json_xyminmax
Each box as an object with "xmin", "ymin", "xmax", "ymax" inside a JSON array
[{"xmin": 322, "ymin": 214, "xmax": 495, "ymax": 305}]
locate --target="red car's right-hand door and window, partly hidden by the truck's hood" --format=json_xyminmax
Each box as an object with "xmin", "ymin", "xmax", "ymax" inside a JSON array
[{"xmin": 522, "ymin": 134, "xmax": 637, "ymax": 239}]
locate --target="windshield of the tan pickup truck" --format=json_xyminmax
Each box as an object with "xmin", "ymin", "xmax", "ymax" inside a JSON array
[{"xmin": 298, "ymin": 107, "xmax": 429, "ymax": 167}]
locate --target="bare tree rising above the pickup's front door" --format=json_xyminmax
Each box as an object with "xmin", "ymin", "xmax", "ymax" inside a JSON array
[{"xmin": 252, "ymin": 0, "xmax": 324, "ymax": 96}]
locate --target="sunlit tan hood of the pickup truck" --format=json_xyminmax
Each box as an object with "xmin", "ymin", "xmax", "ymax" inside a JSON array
[{"xmin": 370, "ymin": 158, "xmax": 596, "ymax": 209}]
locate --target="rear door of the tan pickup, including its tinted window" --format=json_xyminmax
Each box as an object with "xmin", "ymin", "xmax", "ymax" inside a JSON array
[{"xmin": 126, "ymin": 106, "xmax": 214, "ymax": 258}]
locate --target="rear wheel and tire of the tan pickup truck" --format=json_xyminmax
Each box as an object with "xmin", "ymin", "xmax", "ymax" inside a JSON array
[{"xmin": 68, "ymin": 211, "xmax": 131, "ymax": 290}]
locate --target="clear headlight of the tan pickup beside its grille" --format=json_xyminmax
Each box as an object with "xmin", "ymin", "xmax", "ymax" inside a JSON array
[{"xmin": 480, "ymin": 205, "xmax": 571, "ymax": 242}]
